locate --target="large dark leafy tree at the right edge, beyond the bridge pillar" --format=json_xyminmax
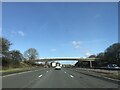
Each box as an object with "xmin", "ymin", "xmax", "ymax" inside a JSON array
[{"xmin": 96, "ymin": 43, "xmax": 120, "ymax": 66}]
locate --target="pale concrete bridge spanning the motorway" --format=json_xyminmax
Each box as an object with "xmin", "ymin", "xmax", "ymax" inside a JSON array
[{"xmin": 35, "ymin": 57, "xmax": 99, "ymax": 67}]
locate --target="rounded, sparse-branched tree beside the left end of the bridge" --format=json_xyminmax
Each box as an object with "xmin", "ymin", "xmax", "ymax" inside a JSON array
[{"xmin": 24, "ymin": 48, "xmax": 38, "ymax": 60}]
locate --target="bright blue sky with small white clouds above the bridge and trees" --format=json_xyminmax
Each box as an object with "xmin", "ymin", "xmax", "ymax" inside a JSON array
[{"xmin": 2, "ymin": 2, "xmax": 118, "ymax": 64}]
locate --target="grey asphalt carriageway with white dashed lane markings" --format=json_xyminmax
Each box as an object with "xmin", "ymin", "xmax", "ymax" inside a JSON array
[{"xmin": 2, "ymin": 68, "xmax": 118, "ymax": 88}]
